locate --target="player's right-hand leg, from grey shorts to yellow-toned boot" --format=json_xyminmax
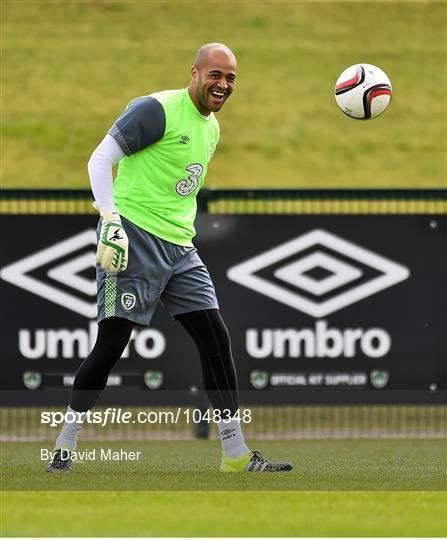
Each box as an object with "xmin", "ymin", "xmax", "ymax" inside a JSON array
[{"xmin": 161, "ymin": 245, "xmax": 293, "ymax": 472}]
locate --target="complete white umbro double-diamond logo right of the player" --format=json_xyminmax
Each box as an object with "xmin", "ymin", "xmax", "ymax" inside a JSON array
[{"xmin": 227, "ymin": 229, "xmax": 410, "ymax": 318}]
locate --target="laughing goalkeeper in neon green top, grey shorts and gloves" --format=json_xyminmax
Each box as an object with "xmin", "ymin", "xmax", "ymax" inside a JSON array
[{"xmin": 47, "ymin": 43, "xmax": 292, "ymax": 472}]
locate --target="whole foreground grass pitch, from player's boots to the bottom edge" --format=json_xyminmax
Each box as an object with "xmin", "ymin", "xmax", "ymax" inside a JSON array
[{"xmin": 2, "ymin": 440, "xmax": 447, "ymax": 536}]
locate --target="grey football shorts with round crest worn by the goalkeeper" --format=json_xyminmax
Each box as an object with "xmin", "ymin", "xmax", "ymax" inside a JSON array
[{"xmin": 96, "ymin": 218, "xmax": 219, "ymax": 326}]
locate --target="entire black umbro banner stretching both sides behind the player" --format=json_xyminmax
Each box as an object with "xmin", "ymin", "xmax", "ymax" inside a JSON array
[{"xmin": 0, "ymin": 215, "xmax": 447, "ymax": 404}]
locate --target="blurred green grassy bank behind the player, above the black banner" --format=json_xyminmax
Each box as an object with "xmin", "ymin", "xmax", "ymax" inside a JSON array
[{"xmin": 2, "ymin": 0, "xmax": 447, "ymax": 191}]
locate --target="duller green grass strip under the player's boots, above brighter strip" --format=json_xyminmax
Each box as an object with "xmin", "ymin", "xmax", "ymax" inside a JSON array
[{"xmin": 2, "ymin": 439, "xmax": 447, "ymax": 491}]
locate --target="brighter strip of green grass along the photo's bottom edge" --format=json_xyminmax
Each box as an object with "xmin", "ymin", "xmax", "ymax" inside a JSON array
[{"xmin": 2, "ymin": 491, "xmax": 447, "ymax": 537}]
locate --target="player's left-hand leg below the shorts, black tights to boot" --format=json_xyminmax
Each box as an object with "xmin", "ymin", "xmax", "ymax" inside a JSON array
[{"xmin": 47, "ymin": 317, "xmax": 133, "ymax": 472}]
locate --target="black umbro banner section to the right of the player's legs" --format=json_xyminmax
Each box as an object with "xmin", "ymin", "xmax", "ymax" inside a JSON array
[{"xmin": 198, "ymin": 215, "xmax": 447, "ymax": 399}]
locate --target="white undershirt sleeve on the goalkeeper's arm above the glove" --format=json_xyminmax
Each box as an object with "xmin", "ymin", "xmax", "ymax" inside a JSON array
[{"xmin": 87, "ymin": 134, "xmax": 125, "ymax": 212}]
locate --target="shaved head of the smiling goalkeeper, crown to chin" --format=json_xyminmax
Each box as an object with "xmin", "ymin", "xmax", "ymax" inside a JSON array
[{"xmin": 188, "ymin": 43, "xmax": 237, "ymax": 116}]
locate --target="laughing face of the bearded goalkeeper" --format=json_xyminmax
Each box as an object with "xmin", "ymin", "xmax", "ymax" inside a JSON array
[{"xmin": 192, "ymin": 50, "xmax": 236, "ymax": 115}]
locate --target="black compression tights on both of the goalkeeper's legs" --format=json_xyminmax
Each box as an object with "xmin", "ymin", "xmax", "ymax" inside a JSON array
[{"xmin": 70, "ymin": 309, "xmax": 238, "ymax": 414}]
